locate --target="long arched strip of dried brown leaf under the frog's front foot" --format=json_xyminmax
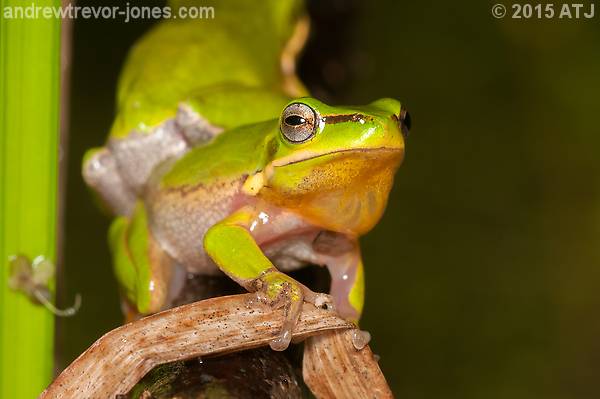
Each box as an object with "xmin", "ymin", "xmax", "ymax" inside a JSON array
[{"xmin": 39, "ymin": 294, "xmax": 352, "ymax": 399}]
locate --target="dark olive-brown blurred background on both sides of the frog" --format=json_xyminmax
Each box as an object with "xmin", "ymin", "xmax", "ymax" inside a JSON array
[{"xmin": 57, "ymin": 0, "xmax": 600, "ymax": 399}]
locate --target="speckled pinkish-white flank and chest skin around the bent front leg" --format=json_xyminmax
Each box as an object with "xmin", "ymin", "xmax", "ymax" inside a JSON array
[{"xmin": 145, "ymin": 175, "xmax": 318, "ymax": 274}]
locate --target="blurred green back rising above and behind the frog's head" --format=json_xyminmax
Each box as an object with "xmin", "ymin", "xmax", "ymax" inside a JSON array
[{"xmin": 111, "ymin": 0, "xmax": 303, "ymax": 137}]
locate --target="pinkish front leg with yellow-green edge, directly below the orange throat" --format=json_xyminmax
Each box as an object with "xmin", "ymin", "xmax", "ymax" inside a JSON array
[{"xmin": 326, "ymin": 250, "xmax": 365, "ymax": 323}]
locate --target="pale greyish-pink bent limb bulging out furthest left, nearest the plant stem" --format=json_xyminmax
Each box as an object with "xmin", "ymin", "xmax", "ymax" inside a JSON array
[{"xmin": 83, "ymin": 148, "xmax": 135, "ymax": 215}]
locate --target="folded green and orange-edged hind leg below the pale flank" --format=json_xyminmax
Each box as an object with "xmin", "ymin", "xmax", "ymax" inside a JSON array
[{"xmin": 109, "ymin": 203, "xmax": 172, "ymax": 314}]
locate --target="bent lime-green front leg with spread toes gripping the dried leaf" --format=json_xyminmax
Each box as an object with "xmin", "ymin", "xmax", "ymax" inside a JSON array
[{"xmin": 204, "ymin": 207, "xmax": 326, "ymax": 350}]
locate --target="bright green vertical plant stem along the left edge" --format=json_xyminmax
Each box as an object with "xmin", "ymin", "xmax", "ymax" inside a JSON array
[{"xmin": 0, "ymin": 0, "xmax": 60, "ymax": 399}]
